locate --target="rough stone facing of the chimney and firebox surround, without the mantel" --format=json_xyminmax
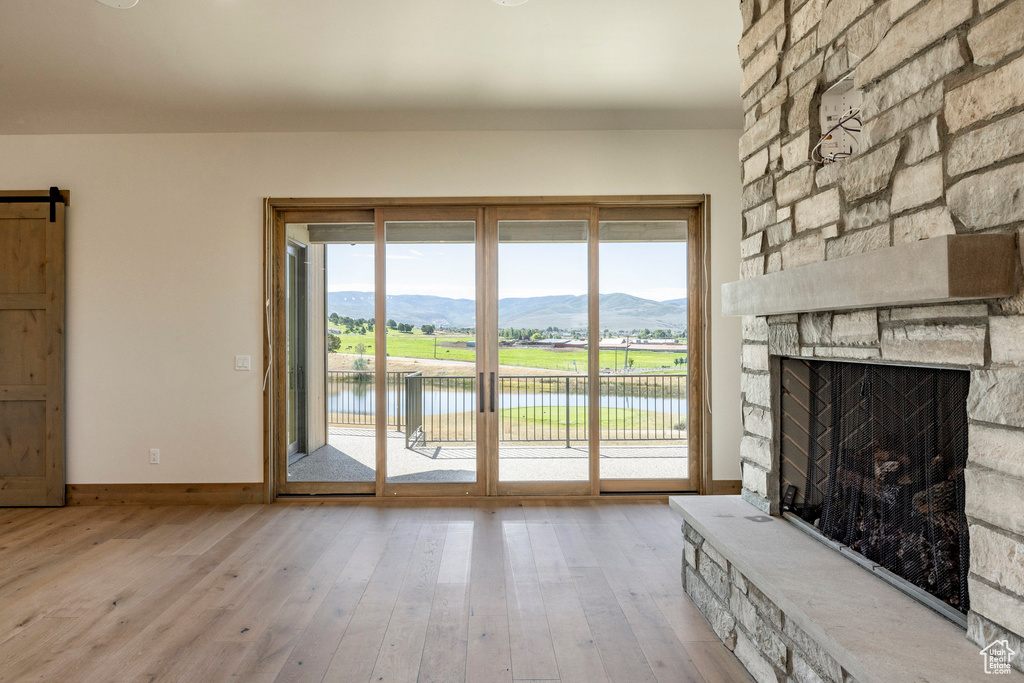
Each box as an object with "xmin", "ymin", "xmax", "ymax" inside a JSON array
[{"xmin": 737, "ymin": 0, "xmax": 1024, "ymax": 668}]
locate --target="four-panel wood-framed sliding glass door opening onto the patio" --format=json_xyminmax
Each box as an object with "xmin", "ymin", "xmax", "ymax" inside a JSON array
[{"xmin": 279, "ymin": 197, "xmax": 700, "ymax": 496}]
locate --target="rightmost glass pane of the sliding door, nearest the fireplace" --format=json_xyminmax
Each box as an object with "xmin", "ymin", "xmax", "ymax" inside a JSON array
[{"xmin": 598, "ymin": 220, "xmax": 688, "ymax": 479}]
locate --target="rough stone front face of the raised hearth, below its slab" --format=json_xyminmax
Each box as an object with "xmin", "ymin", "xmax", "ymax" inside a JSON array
[{"xmin": 683, "ymin": 521, "xmax": 856, "ymax": 683}]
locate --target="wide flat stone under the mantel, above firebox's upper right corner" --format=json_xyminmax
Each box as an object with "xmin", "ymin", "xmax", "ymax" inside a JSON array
[{"xmin": 882, "ymin": 324, "xmax": 985, "ymax": 366}]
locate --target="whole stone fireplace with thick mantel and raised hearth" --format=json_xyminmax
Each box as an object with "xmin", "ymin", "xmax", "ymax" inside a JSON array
[{"xmin": 678, "ymin": 0, "xmax": 1024, "ymax": 683}]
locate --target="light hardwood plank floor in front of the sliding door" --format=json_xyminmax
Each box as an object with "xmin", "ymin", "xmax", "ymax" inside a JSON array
[{"xmin": 0, "ymin": 502, "xmax": 751, "ymax": 683}]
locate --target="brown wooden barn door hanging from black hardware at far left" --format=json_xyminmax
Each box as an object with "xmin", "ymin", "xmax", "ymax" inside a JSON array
[{"xmin": 0, "ymin": 188, "xmax": 67, "ymax": 506}]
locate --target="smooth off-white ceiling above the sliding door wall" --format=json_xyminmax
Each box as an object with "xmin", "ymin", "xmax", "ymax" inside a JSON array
[{"xmin": 0, "ymin": 0, "xmax": 742, "ymax": 133}]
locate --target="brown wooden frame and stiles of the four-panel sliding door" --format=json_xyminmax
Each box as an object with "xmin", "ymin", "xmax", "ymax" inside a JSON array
[{"xmin": 263, "ymin": 195, "xmax": 713, "ymax": 502}]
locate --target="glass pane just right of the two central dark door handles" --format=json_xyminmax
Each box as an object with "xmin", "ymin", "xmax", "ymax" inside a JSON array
[{"xmin": 496, "ymin": 220, "xmax": 590, "ymax": 482}]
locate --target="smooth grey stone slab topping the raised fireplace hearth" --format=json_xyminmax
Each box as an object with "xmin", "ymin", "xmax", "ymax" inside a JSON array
[{"xmin": 669, "ymin": 496, "xmax": 1024, "ymax": 683}]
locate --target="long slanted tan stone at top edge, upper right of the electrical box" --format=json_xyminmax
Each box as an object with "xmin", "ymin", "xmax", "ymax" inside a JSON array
[{"xmin": 851, "ymin": 0, "xmax": 974, "ymax": 86}]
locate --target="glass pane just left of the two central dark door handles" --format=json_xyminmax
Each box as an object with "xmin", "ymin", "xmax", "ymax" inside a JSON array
[{"xmin": 384, "ymin": 222, "xmax": 478, "ymax": 484}]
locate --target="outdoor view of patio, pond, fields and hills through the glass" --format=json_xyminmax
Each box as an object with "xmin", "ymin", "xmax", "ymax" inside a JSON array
[{"xmin": 289, "ymin": 228, "xmax": 687, "ymax": 482}]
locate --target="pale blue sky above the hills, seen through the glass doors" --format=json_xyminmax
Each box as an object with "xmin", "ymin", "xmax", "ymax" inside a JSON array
[{"xmin": 327, "ymin": 243, "xmax": 686, "ymax": 301}]
